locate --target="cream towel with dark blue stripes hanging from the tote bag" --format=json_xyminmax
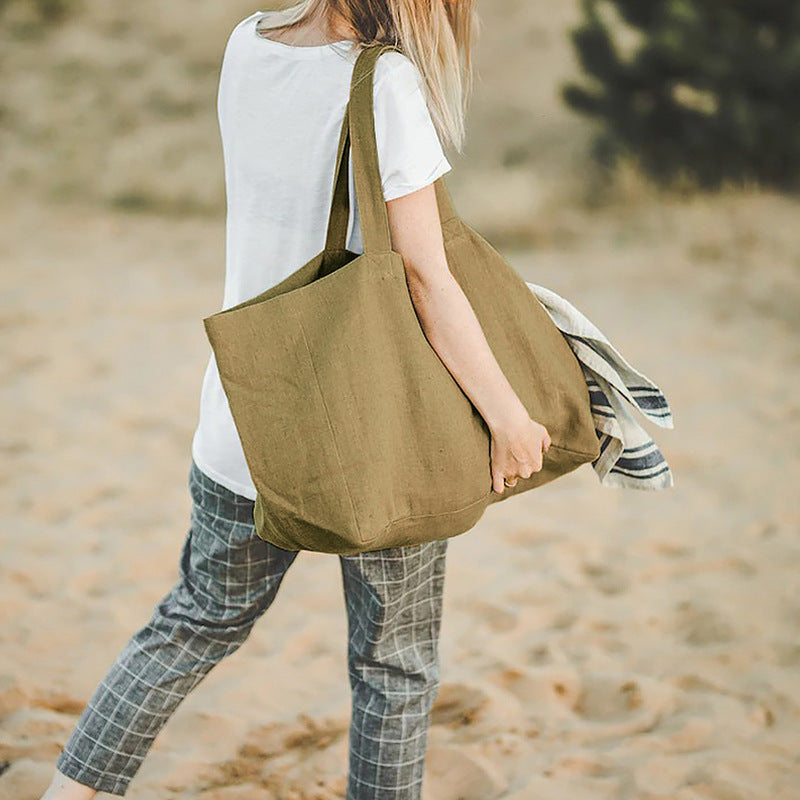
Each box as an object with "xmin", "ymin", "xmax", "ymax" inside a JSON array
[{"xmin": 527, "ymin": 283, "xmax": 675, "ymax": 490}]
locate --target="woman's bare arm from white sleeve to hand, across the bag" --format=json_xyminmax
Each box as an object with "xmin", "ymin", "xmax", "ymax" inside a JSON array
[{"xmin": 386, "ymin": 184, "xmax": 550, "ymax": 492}]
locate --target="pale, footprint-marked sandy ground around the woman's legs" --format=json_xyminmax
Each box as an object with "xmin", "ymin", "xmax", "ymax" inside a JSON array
[{"xmin": 0, "ymin": 186, "xmax": 800, "ymax": 800}]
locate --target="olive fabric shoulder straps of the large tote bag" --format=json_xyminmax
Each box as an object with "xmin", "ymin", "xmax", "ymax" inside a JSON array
[{"xmin": 325, "ymin": 43, "xmax": 457, "ymax": 253}]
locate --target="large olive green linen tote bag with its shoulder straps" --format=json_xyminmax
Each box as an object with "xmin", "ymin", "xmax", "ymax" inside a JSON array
[{"xmin": 203, "ymin": 45, "xmax": 600, "ymax": 554}]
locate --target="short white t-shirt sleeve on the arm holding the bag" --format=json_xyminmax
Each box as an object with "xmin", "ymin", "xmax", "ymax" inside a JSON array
[{"xmin": 373, "ymin": 50, "xmax": 452, "ymax": 201}]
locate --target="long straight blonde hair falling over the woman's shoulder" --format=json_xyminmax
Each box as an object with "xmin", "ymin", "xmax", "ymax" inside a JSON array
[{"xmin": 259, "ymin": 0, "xmax": 480, "ymax": 153}]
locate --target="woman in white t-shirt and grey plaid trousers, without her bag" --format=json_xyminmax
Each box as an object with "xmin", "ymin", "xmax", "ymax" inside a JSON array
[{"xmin": 39, "ymin": 0, "xmax": 550, "ymax": 800}]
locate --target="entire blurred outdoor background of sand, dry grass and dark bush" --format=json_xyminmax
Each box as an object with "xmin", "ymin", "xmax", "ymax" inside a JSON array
[{"xmin": 0, "ymin": 0, "xmax": 800, "ymax": 800}]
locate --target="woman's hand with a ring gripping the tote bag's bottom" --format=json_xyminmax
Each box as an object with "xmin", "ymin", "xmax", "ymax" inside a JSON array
[{"xmin": 490, "ymin": 413, "xmax": 550, "ymax": 494}]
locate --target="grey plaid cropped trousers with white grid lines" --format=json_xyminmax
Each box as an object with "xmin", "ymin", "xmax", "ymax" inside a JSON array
[{"xmin": 56, "ymin": 460, "xmax": 448, "ymax": 800}]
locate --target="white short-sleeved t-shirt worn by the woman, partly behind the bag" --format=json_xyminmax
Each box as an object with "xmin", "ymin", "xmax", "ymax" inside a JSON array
[{"xmin": 192, "ymin": 11, "xmax": 451, "ymax": 500}]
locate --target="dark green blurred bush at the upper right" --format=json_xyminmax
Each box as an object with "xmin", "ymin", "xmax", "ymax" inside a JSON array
[{"xmin": 562, "ymin": 0, "xmax": 800, "ymax": 190}]
